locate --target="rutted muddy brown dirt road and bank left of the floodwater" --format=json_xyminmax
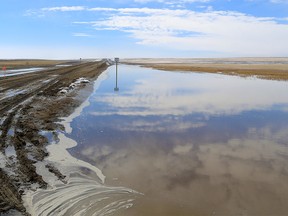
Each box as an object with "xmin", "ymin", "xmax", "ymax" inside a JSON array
[{"xmin": 0, "ymin": 61, "xmax": 108, "ymax": 215}]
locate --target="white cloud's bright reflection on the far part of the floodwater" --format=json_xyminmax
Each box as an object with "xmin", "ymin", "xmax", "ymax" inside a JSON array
[{"xmin": 89, "ymin": 67, "xmax": 288, "ymax": 118}]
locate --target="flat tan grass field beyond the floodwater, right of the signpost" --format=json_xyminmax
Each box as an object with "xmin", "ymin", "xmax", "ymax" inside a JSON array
[{"xmin": 122, "ymin": 58, "xmax": 288, "ymax": 80}]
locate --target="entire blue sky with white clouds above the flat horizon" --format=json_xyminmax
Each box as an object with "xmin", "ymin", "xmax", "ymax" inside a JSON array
[{"xmin": 0, "ymin": 0, "xmax": 288, "ymax": 59}]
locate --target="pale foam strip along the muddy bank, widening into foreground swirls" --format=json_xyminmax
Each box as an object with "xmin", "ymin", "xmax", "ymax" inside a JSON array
[{"xmin": 22, "ymin": 71, "xmax": 138, "ymax": 216}]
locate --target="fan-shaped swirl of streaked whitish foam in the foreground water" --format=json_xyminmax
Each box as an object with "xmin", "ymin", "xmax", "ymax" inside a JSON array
[{"xmin": 25, "ymin": 175, "xmax": 137, "ymax": 216}]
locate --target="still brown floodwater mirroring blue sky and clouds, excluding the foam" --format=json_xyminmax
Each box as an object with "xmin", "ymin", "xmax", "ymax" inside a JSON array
[{"xmin": 72, "ymin": 65, "xmax": 288, "ymax": 215}]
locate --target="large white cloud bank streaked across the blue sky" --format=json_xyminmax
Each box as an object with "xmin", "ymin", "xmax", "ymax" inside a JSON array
[{"xmin": 75, "ymin": 8, "xmax": 288, "ymax": 56}]
